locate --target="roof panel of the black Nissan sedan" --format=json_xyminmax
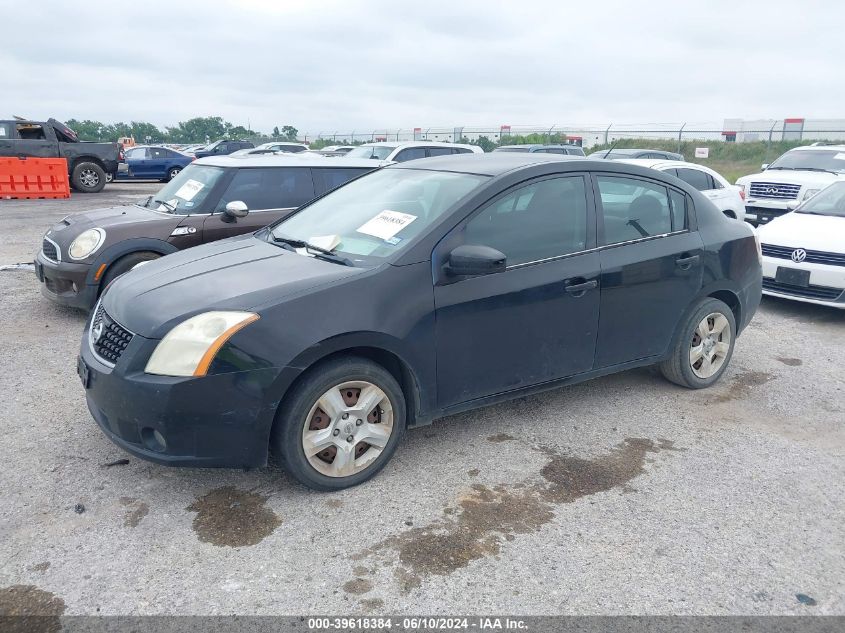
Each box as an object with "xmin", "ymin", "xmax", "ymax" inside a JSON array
[{"xmin": 390, "ymin": 152, "xmax": 588, "ymax": 176}]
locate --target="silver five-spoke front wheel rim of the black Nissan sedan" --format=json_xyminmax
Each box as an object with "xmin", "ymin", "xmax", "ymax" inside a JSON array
[{"xmin": 302, "ymin": 380, "xmax": 393, "ymax": 477}]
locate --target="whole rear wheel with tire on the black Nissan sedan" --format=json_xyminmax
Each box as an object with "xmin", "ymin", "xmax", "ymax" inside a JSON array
[{"xmin": 660, "ymin": 297, "xmax": 736, "ymax": 389}]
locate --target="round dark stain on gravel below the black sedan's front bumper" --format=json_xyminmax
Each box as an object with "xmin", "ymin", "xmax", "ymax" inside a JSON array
[{"xmin": 186, "ymin": 486, "xmax": 282, "ymax": 547}]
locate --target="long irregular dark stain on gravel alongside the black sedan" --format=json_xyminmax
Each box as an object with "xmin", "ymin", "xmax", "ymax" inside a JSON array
[{"xmin": 344, "ymin": 438, "xmax": 685, "ymax": 592}]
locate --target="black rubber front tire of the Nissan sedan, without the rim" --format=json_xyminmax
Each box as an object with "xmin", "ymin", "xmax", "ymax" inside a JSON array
[{"xmin": 271, "ymin": 357, "xmax": 406, "ymax": 490}]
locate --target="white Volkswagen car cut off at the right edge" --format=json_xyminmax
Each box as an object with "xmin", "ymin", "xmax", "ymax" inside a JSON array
[{"xmin": 757, "ymin": 181, "xmax": 845, "ymax": 309}]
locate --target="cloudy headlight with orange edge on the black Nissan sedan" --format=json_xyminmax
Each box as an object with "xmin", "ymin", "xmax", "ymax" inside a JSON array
[{"xmin": 144, "ymin": 312, "xmax": 258, "ymax": 376}]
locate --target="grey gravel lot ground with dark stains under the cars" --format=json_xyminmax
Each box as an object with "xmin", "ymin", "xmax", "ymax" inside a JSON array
[{"xmin": 0, "ymin": 183, "xmax": 845, "ymax": 615}]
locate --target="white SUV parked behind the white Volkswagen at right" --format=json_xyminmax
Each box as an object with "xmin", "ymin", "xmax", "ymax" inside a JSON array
[{"xmin": 736, "ymin": 145, "xmax": 845, "ymax": 224}]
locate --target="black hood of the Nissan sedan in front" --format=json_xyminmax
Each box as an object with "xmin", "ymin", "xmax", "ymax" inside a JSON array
[{"xmin": 103, "ymin": 235, "xmax": 364, "ymax": 339}]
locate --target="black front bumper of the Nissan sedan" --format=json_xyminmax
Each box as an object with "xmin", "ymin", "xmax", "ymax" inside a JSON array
[{"xmin": 79, "ymin": 327, "xmax": 279, "ymax": 467}]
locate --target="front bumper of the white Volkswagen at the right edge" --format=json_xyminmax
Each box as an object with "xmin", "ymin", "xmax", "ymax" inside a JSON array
[{"xmin": 763, "ymin": 255, "xmax": 845, "ymax": 309}]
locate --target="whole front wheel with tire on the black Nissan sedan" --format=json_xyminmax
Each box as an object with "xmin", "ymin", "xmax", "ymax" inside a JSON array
[{"xmin": 270, "ymin": 356, "xmax": 406, "ymax": 490}]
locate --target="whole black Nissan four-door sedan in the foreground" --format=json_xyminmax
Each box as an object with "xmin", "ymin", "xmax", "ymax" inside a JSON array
[{"xmin": 78, "ymin": 153, "xmax": 761, "ymax": 490}]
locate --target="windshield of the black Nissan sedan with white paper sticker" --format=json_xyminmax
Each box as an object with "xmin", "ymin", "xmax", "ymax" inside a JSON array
[{"xmin": 272, "ymin": 169, "xmax": 489, "ymax": 262}]
